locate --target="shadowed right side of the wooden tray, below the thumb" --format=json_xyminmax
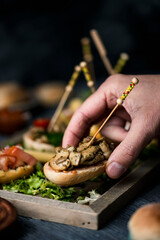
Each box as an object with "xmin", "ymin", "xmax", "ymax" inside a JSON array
[{"xmin": 90, "ymin": 158, "xmax": 160, "ymax": 229}]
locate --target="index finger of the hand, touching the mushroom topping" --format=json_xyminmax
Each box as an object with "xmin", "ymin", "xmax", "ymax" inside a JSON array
[{"xmin": 63, "ymin": 88, "xmax": 107, "ymax": 147}]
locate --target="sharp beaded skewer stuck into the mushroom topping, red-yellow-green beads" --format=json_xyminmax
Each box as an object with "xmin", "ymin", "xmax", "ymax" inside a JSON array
[{"xmin": 87, "ymin": 78, "xmax": 139, "ymax": 147}]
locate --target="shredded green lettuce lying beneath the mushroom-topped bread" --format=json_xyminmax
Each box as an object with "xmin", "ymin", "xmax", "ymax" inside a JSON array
[{"xmin": 2, "ymin": 164, "xmax": 105, "ymax": 204}]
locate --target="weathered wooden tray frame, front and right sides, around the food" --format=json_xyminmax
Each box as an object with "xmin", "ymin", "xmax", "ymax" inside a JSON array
[{"xmin": 0, "ymin": 134, "xmax": 160, "ymax": 230}]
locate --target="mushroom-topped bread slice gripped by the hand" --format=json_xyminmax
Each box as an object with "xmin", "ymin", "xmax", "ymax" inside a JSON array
[{"xmin": 44, "ymin": 136, "xmax": 114, "ymax": 186}]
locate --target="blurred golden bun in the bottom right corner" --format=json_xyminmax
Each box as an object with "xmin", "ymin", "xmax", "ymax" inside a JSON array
[{"xmin": 128, "ymin": 203, "xmax": 160, "ymax": 240}]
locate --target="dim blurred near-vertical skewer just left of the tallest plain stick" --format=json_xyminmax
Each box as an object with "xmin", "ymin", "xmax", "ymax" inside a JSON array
[{"xmin": 81, "ymin": 37, "xmax": 96, "ymax": 82}]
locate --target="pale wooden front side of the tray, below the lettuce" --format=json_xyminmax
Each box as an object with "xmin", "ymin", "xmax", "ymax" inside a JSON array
[{"xmin": 0, "ymin": 190, "xmax": 98, "ymax": 229}]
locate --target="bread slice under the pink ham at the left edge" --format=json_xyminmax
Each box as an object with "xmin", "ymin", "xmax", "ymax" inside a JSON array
[{"xmin": 0, "ymin": 165, "xmax": 34, "ymax": 184}]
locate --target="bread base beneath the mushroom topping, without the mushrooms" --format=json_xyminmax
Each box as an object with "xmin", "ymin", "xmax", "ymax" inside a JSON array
[{"xmin": 43, "ymin": 161, "xmax": 107, "ymax": 186}]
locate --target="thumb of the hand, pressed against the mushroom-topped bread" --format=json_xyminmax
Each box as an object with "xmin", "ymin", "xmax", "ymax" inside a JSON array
[{"xmin": 106, "ymin": 119, "xmax": 152, "ymax": 178}]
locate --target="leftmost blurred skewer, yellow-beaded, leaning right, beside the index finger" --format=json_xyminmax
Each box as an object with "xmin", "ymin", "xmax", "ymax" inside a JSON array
[{"xmin": 48, "ymin": 66, "xmax": 81, "ymax": 132}]
